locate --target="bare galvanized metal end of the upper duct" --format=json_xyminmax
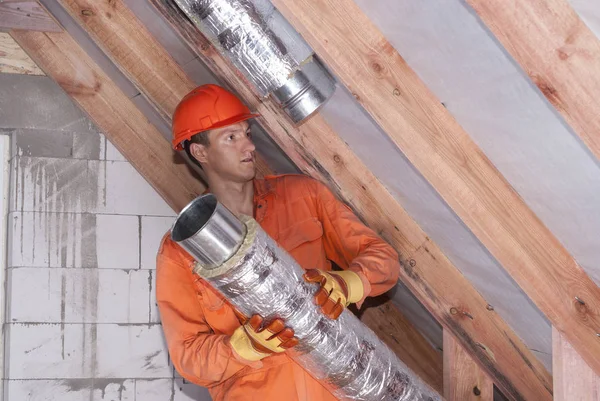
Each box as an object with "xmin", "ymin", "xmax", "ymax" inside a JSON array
[{"xmin": 272, "ymin": 55, "xmax": 336, "ymax": 123}]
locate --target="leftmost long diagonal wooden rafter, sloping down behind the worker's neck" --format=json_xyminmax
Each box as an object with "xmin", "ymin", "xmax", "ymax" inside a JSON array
[{"xmin": 11, "ymin": 31, "xmax": 205, "ymax": 211}]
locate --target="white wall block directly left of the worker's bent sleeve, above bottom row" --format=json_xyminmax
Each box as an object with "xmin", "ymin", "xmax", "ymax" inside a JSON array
[{"xmin": 96, "ymin": 324, "xmax": 172, "ymax": 379}]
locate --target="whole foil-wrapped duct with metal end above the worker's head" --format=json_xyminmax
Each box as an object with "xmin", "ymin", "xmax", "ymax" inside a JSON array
[{"xmin": 175, "ymin": 0, "xmax": 335, "ymax": 123}]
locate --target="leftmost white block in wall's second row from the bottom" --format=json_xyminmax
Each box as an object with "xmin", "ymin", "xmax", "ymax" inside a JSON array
[{"xmin": 5, "ymin": 323, "xmax": 98, "ymax": 379}]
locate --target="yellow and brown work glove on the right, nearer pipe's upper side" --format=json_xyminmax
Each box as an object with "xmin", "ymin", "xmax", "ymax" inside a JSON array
[{"xmin": 304, "ymin": 269, "xmax": 364, "ymax": 319}]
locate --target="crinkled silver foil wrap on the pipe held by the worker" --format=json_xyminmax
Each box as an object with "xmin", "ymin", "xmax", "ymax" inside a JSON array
[{"xmin": 195, "ymin": 218, "xmax": 442, "ymax": 401}]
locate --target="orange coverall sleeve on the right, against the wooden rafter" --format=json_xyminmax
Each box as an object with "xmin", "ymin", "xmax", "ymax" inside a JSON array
[{"xmin": 314, "ymin": 180, "xmax": 400, "ymax": 296}]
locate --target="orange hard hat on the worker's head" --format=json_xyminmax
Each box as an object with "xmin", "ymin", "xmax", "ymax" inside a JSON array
[{"xmin": 173, "ymin": 84, "xmax": 260, "ymax": 150}]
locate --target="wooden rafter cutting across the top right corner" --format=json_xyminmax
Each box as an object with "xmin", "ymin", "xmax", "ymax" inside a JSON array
[{"xmin": 466, "ymin": 0, "xmax": 600, "ymax": 164}]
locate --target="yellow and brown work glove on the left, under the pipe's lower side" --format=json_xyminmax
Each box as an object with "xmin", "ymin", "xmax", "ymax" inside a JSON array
[{"xmin": 229, "ymin": 315, "xmax": 298, "ymax": 361}]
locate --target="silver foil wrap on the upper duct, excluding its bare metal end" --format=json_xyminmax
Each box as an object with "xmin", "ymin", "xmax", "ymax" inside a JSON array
[{"xmin": 175, "ymin": 0, "xmax": 304, "ymax": 97}]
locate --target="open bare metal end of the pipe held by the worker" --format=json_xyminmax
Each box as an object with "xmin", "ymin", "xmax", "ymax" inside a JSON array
[{"xmin": 171, "ymin": 194, "xmax": 246, "ymax": 269}]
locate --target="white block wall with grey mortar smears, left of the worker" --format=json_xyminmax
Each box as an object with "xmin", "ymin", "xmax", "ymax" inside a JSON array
[{"xmin": 0, "ymin": 74, "xmax": 210, "ymax": 401}]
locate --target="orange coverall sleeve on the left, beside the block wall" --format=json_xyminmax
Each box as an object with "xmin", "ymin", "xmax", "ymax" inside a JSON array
[{"xmin": 156, "ymin": 236, "xmax": 248, "ymax": 387}]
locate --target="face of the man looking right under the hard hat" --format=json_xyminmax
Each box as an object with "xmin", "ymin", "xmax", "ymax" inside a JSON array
[{"xmin": 192, "ymin": 121, "xmax": 256, "ymax": 182}]
